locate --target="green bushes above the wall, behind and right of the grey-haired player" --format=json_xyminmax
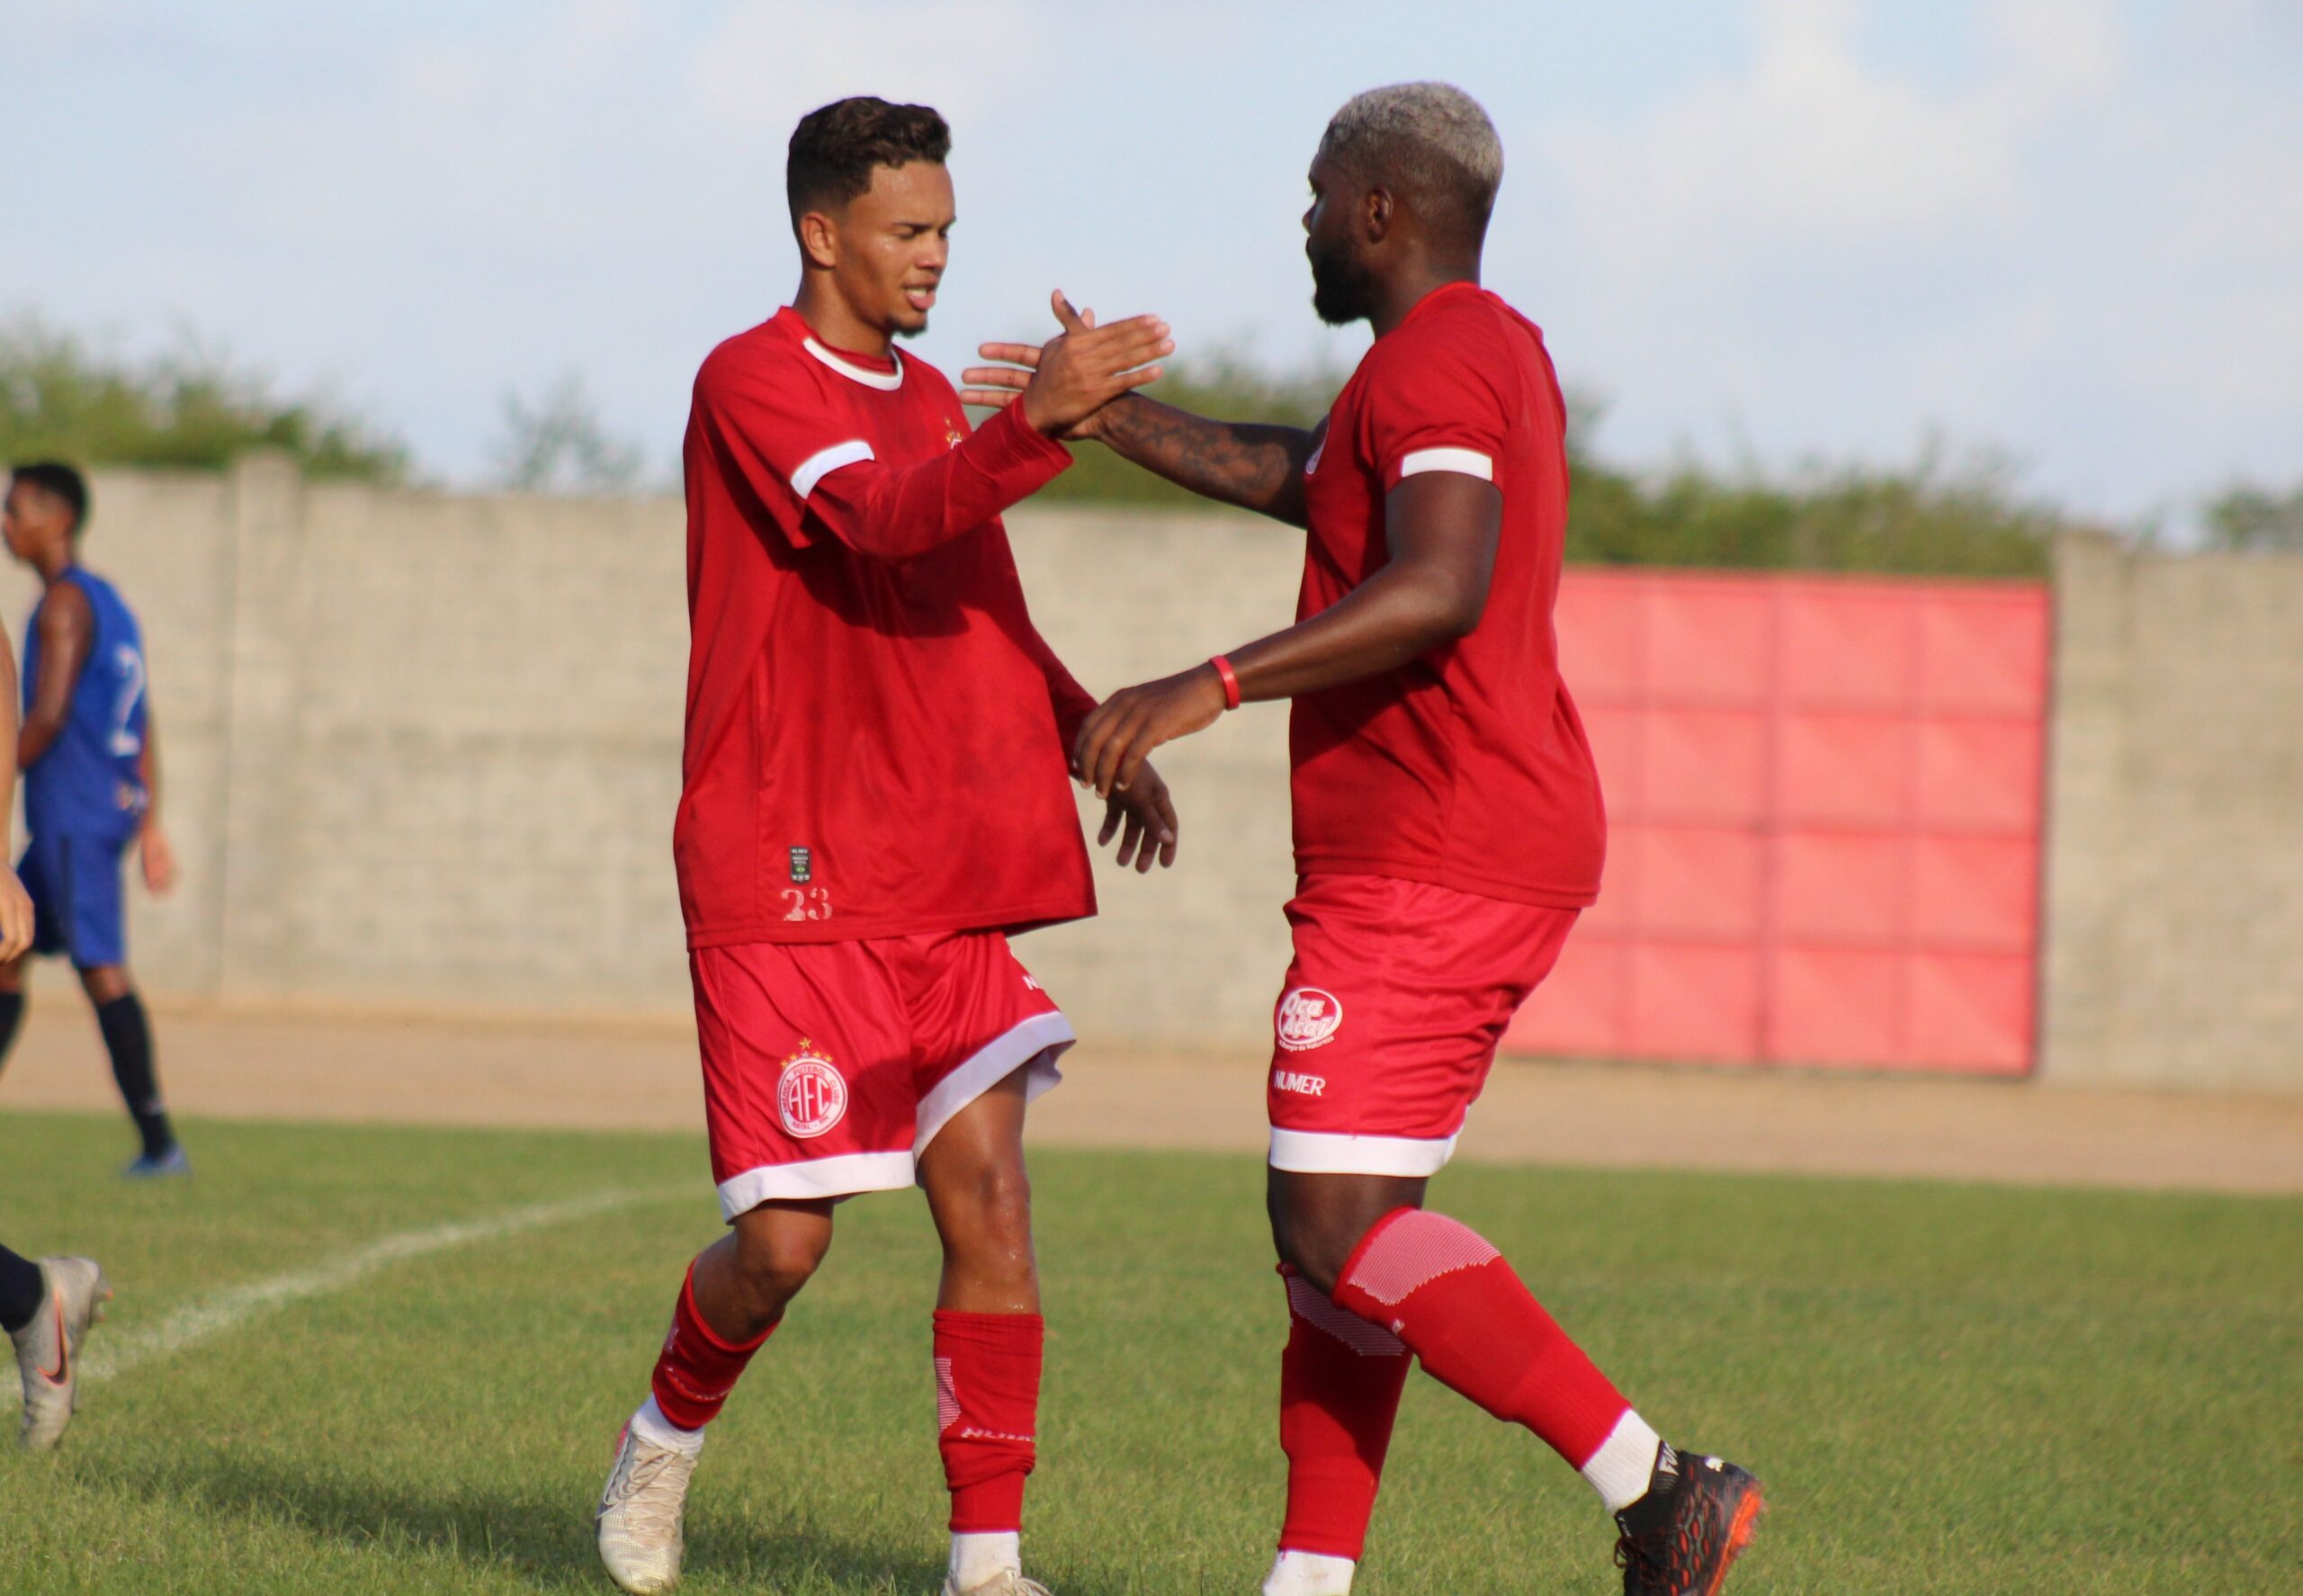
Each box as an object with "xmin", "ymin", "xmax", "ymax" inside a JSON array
[{"xmin": 1017, "ymin": 357, "xmax": 2064, "ymax": 576}]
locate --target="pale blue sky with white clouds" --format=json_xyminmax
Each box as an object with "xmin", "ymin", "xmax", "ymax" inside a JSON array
[{"xmin": 0, "ymin": 0, "xmax": 2303, "ymax": 523}]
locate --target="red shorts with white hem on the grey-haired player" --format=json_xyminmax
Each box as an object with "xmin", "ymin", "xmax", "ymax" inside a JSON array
[{"xmin": 1264, "ymin": 875, "xmax": 1575, "ymax": 1175}]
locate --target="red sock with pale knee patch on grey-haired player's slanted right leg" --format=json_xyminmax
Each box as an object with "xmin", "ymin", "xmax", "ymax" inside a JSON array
[{"xmin": 1336, "ymin": 1209, "xmax": 1630, "ymax": 1469}]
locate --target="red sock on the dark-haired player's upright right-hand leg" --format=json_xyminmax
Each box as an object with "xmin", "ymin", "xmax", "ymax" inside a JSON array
[{"xmin": 935, "ymin": 1308, "xmax": 1045, "ymax": 1534}]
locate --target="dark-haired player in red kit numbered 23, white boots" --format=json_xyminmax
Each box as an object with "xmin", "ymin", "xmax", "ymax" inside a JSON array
[{"xmin": 599, "ymin": 99, "xmax": 1177, "ymax": 1596}]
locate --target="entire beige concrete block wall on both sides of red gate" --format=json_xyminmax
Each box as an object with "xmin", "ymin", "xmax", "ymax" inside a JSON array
[{"xmin": 18, "ymin": 456, "xmax": 2303, "ymax": 1089}]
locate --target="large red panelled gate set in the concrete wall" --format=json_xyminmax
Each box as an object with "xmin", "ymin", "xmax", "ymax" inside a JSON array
[{"xmin": 1506, "ymin": 569, "xmax": 2049, "ymax": 1073}]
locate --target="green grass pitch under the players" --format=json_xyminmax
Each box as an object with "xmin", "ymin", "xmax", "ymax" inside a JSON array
[{"xmin": 0, "ymin": 1115, "xmax": 2303, "ymax": 1596}]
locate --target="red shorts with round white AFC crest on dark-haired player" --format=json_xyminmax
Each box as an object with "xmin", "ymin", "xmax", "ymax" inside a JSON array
[{"xmin": 688, "ymin": 930, "xmax": 1073, "ymax": 1221}]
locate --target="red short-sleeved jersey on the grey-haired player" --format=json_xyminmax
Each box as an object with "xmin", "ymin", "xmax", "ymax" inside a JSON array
[{"xmin": 1290, "ymin": 283, "xmax": 1608, "ymax": 908}]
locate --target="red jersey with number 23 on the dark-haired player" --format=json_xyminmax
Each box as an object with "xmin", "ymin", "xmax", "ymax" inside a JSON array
[{"xmin": 673, "ymin": 309, "xmax": 1097, "ymax": 946}]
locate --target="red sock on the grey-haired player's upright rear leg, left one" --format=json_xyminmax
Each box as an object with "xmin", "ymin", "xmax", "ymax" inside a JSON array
[{"xmin": 1280, "ymin": 1264, "xmax": 1410, "ymax": 1562}]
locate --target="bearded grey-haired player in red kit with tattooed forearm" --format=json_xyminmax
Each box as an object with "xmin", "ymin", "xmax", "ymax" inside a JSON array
[{"xmin": 967, "ymin": 83, "xmax": 1761, "ymax": 1596}]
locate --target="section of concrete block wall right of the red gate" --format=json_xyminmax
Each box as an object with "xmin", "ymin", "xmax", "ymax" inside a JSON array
[{"xmin": 2040, "ymin": 534, "xmax": 2303, "ymax": 1089}]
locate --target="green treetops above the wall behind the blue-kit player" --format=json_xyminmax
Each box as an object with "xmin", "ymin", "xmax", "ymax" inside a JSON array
[{"xmin": 0, "ymin": 318, "xmax": 408, "ymax": 484}]
